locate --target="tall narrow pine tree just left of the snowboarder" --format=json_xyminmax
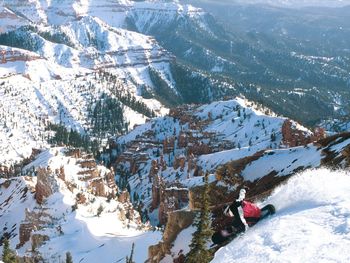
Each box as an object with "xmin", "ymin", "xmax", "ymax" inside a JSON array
[{"xmin": 185, "ymin": 174, "xmax": 213, "ymax": 263}]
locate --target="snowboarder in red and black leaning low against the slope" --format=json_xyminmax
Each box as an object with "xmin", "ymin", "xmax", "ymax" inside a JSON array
[{"xmin": 222, "ymin": 189, "xmax": 261, "ymax": 235}]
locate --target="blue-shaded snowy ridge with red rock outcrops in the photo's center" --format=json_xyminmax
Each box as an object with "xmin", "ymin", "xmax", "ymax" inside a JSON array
[{"xmin": 113, "ymin": 99, "xmax": 317, "ymax": 218}]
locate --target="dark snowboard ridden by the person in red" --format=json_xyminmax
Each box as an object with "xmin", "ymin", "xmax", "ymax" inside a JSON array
[{"xmin": 211, "ymin": 204, "xmax": 276, "ymax": 246}]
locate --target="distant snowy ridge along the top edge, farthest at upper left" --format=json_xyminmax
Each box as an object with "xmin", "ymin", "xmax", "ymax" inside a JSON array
[{"xmin": 0, "ymin": 0, "xmax": 202, "ymax": 27}]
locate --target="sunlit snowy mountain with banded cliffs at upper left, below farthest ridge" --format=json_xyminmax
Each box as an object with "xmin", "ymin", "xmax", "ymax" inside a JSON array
[{"xmin": 0, "ymin": 11, "xmax": 171, "ymax": 163}]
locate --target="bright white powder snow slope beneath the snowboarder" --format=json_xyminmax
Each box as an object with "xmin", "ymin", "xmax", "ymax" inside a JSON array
[{"xmin": 212, "ymin": 169, "xmax": 350, "ymax": 263}]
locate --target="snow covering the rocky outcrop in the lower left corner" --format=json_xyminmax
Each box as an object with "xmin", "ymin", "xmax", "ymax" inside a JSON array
[{"xmin": 0, "ymin": 148, "xmax": 160, "ymax": 262}]
